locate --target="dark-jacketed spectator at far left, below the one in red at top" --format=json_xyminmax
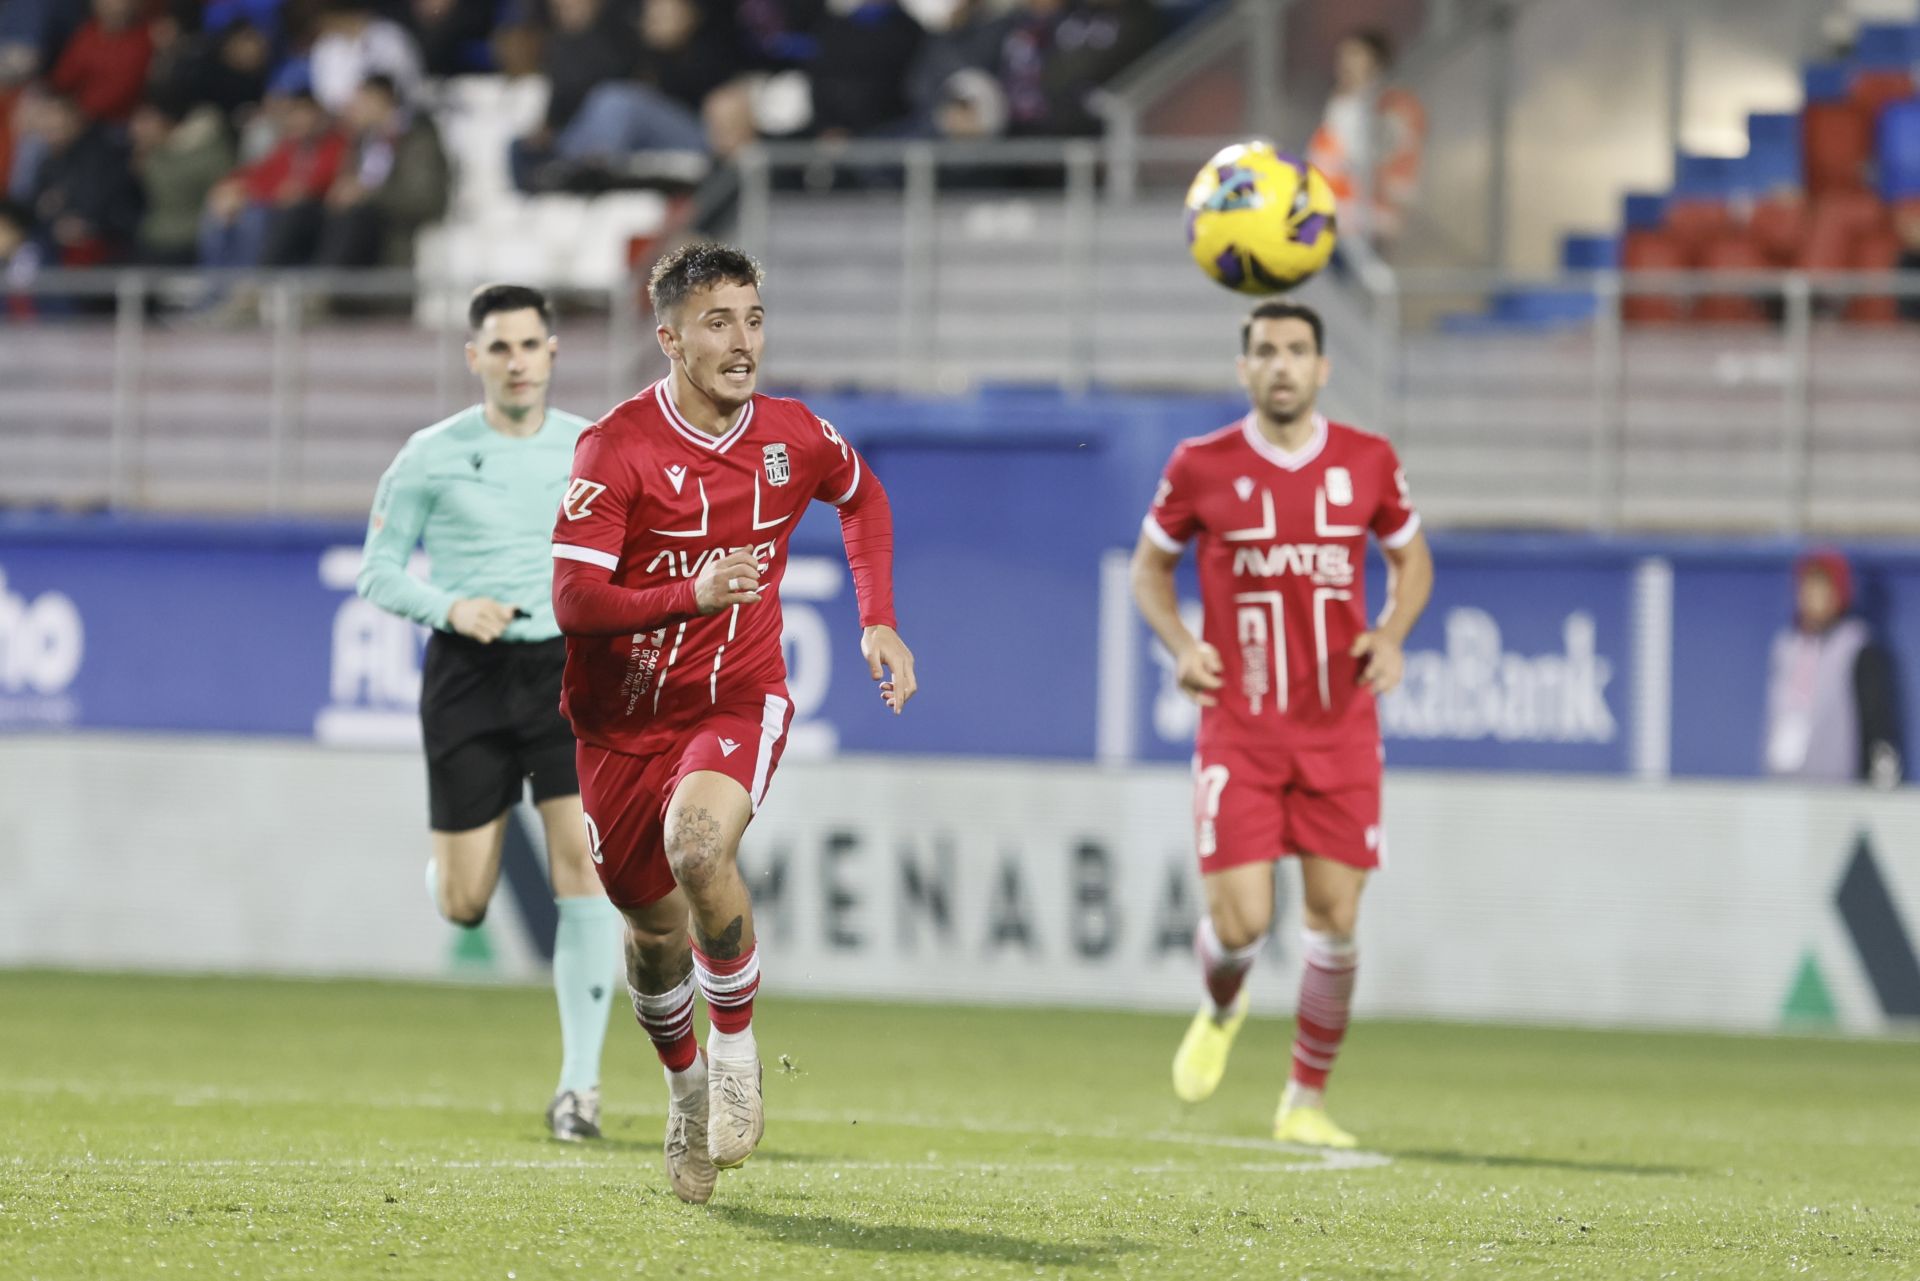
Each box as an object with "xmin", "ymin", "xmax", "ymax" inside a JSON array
[{"xmin": 27, "ymin": 94, "xmax": 140, "ymax": 267}]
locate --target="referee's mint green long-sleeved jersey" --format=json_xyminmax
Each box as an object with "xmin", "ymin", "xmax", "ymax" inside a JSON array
[{"xmin": 359, "ymin": 405, "xmax": 589, "ymax": 641}]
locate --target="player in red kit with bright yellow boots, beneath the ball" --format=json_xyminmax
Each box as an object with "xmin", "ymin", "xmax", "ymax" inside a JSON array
[{"xmin": 1133, "ymin": 302, "xmax": 1432, "ymax": 1147}]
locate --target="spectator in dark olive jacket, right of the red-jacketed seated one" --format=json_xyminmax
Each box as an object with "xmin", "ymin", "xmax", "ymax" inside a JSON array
[{"xmin": 313, "ymin": 75, "xmax": 451, "ymax": 267}]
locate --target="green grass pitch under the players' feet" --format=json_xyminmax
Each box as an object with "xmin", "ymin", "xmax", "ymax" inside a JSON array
[{"xmin": 0, "ymin": 972, "xmax": 1920, "ymax": 1281}]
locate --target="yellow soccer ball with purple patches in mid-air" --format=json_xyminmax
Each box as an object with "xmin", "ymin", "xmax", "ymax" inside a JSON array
[{"xmin": 1187, "ymin": 142, "xmax": 1336, "ymax": 294}]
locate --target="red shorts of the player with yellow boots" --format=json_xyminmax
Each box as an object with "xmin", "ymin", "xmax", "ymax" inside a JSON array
[{"xmin": 1194, "ymin": 739, "xmax": 1386, "ymax": 876}]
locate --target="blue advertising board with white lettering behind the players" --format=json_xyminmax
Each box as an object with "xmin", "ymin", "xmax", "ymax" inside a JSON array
[{"xmin": 0, "ymin": 387, "xmax": 1920, "ymax": 778}]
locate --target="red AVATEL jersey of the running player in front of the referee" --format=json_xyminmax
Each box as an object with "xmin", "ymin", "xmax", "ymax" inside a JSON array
[{"xmin": 553, "ymin": 378, "xmax": 877, "ymax": 755}]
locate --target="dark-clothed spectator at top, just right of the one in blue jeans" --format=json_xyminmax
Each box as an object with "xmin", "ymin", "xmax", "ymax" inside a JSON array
[{"xmin": 806, "ymin": 0, "xmax": 925, "ymax": 138}]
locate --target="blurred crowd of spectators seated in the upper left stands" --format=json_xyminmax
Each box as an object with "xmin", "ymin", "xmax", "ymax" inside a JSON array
[{"xmin": 0, "ymin": 0, "xmax": 1162, "ymax": 277}]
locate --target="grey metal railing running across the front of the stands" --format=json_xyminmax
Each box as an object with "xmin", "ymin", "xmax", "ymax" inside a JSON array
[{"xmin": 0, "ymin": 164, "xmax": 1920, "ymax": 532}]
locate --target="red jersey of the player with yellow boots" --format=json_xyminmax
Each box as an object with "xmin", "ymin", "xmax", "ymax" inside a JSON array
[{"xmin": 1142, "ymin": 415, "xmax": 1421, "ymax": 747}]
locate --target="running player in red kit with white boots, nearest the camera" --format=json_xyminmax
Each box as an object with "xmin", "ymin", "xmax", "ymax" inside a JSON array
[{"xmin": 553, "ymin": 244, "xmax": 916, "ymax": 1202}]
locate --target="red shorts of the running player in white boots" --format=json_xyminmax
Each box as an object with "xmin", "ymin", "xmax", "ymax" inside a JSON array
[{"xmin": 574, "ymin": 693, "xmax": 793, "ymax": 906}]
